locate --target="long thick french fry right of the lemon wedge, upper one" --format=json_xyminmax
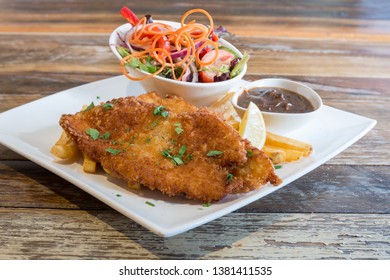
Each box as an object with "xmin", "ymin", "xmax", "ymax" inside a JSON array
[{"xmin": 265, "ymin": 132, "xmax": 313, "ymax": 157}]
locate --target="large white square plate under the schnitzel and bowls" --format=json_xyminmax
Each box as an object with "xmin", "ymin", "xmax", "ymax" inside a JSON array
[{"xmin": 0, "ymin": 76, "xmax": 376, "ymax": 237}]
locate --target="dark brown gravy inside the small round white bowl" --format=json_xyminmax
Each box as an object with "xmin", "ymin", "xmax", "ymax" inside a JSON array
[{"xmin": 237, "ymin": 87, "xmax": 314, "ymax": 113}]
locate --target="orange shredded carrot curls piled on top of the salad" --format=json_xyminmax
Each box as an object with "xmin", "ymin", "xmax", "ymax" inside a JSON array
[{"xmin": 121, "ymin": 9, "xmax": 219, "ymax": 81}]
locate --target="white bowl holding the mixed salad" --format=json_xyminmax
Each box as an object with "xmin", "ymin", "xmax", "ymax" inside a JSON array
[{"xmin": 109, "ymin": 21, "xmax": 247, "ymax": 106}]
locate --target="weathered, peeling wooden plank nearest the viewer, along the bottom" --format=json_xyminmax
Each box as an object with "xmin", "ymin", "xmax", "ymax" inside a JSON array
[{"xmin": 0, "ymin": 208, "xmax": 390, "ymax": 259}]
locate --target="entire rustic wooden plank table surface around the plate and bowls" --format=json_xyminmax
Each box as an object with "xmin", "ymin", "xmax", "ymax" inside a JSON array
[{"xmin": 0, "ymin": 0, "xmax": 390, "ymax": 259}]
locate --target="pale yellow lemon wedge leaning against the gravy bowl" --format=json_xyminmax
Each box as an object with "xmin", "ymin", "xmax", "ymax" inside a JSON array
[{"xmin": 239, "ymin": 102, "xmax": 266, "ymax": 149}]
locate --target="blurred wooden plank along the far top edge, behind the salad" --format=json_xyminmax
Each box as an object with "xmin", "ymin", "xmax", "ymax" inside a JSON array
[{"xmin": 0, "ymin": 0, "xmax": 390, "ymax": 41}]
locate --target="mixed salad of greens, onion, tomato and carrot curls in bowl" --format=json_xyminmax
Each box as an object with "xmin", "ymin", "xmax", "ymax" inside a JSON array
[{"xmin": 116, "ymin": 7, "xmax": 249, "ymax": 83}]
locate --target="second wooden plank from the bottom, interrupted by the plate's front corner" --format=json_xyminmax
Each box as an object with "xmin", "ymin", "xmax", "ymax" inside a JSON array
[{"xmin": 0, "ymin": 161, "xmax": 390, "ymax": 214}]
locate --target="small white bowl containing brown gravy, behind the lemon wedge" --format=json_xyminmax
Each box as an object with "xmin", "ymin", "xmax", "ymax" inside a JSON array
[{"xmin": 232, "ymin": 78, "xmax": 323, "ymax": 133}]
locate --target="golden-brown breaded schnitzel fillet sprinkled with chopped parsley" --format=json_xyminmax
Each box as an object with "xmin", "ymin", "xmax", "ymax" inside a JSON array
[{"xmin": 60, "ymin": 93, "xmax": 281, "ymax": 202}]
